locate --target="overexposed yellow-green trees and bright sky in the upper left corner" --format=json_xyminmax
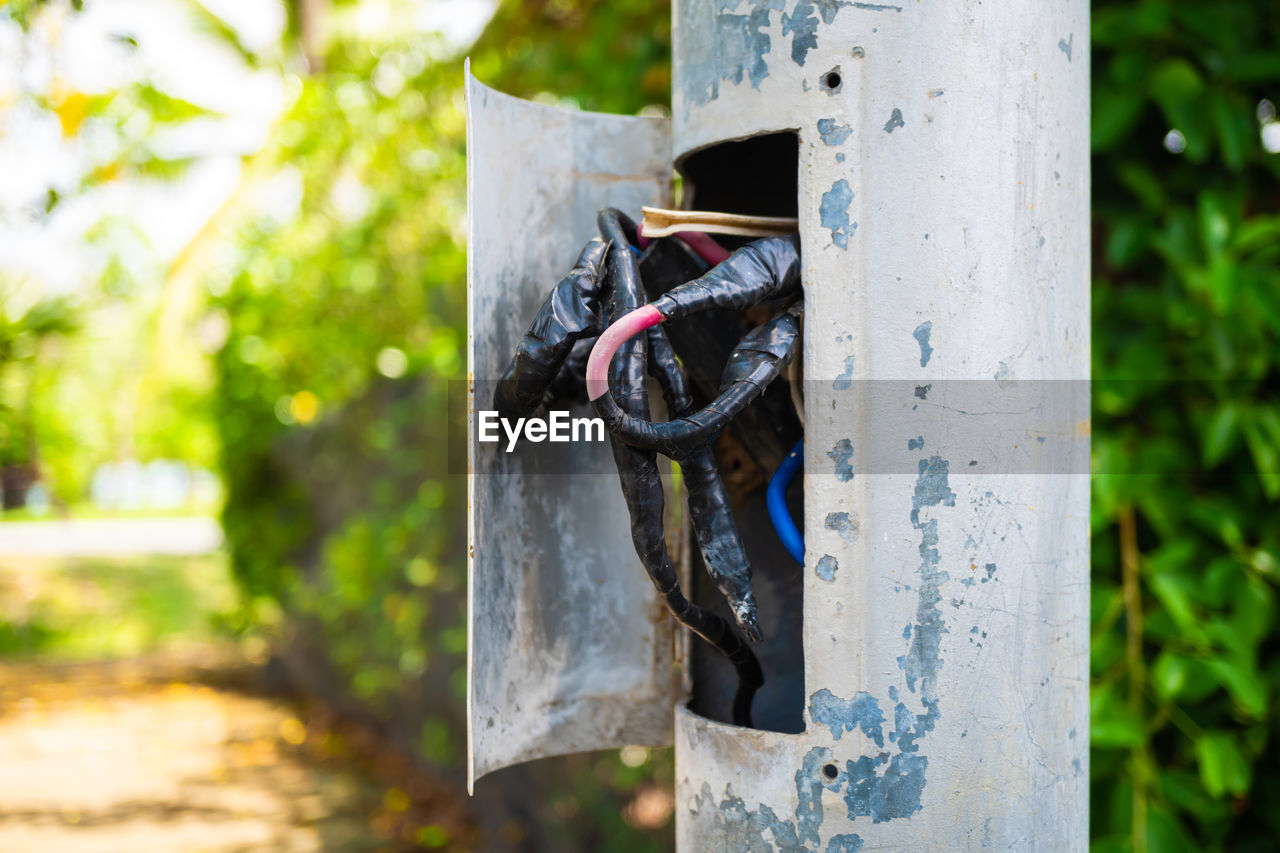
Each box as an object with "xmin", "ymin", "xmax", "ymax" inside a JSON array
[{"xmin": 0, "ymin": 0, "xmax": 284, "ymax": 505}]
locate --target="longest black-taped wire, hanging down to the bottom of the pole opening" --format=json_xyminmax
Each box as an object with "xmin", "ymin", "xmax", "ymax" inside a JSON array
[{"xmin": 599, "ymin": 210, "xmax": 764, "ymax": 726}]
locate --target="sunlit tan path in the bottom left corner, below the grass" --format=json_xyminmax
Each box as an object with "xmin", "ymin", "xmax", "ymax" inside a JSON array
[{"xmin": 0, "ymin": 650, "xmax": 392, "ymax": 853}]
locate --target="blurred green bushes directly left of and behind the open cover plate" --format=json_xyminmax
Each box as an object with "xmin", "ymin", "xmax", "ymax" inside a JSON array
[{"xmin": 217, "ymin": 1, "xmax": 669, "ymax": 850}]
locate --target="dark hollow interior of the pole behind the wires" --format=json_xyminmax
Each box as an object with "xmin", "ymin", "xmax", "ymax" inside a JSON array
[{"xmin": 672, "ymin": 132, "xmax": 804, "ymax": 733}]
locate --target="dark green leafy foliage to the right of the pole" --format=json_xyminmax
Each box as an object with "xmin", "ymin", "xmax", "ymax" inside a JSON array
[{"xmin": 1091, "ymin": 0, "xmax": 1280, "ymax": 852}]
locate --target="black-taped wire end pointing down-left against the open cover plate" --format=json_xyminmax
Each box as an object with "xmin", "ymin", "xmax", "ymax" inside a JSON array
[{"xmin": 493, "ymin": 238, "xmax": 607, "ymax": 420}]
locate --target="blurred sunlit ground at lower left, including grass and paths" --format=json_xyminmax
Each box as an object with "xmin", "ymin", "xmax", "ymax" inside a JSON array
[{"xmin": 0, "ymin": 540, "xmax": 476, "ymax": 853}]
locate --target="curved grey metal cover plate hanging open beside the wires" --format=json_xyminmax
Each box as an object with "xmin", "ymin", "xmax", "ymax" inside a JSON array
[{"xmin": 467, "ymin": 73, "xmax": 678, "ymax": 783}]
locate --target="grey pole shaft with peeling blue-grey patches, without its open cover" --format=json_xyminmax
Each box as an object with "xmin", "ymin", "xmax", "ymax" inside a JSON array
[{"xmin": 672, "ymin": 0, "xmax": 1089, "ymax": 853}]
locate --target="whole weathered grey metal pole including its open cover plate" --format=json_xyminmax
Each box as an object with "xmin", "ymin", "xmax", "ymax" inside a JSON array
[{"xmin": 468, "ymin": 0, "xmax": 1089, "ymax": 853}]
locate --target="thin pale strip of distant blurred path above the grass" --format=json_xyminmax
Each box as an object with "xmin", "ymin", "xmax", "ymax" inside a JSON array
[{"xmin": 0, "ymin": 517, "xmax": 223, "ymax": 557}]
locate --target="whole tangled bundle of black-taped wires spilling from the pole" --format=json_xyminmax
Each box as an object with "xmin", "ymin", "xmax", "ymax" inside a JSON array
[{"xmin": 494, "ymin": 209, "xmax": 800, "ymax": 726}]
